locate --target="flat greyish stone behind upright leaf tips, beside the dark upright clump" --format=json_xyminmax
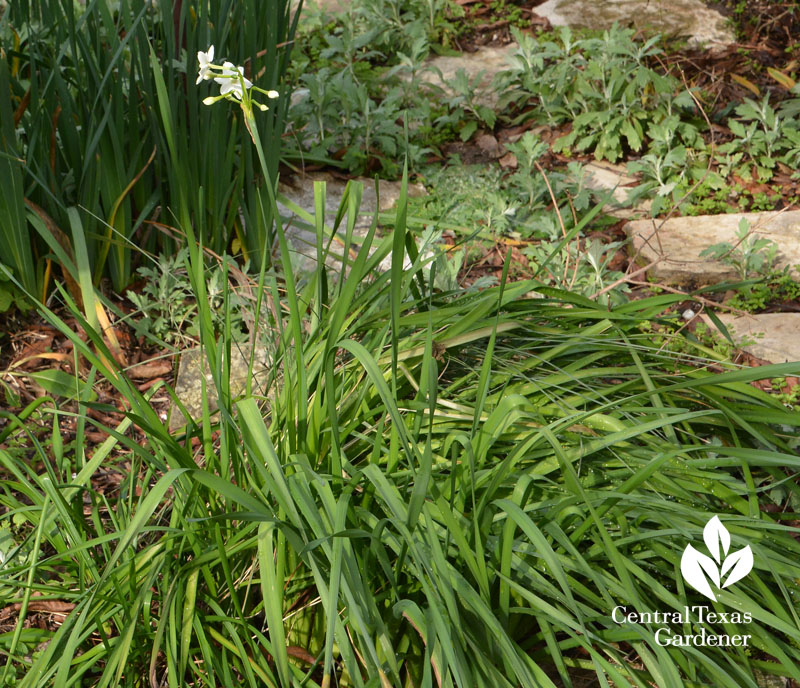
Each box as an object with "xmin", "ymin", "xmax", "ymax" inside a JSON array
[{"xmin": 278, "ymin": 172, "xmax": 427, "ymax": 272}]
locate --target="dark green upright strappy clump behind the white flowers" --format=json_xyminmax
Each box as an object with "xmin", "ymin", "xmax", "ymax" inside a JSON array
[{"xmin": 0, "ymin": 0, "xmax": 298, "ymax": 296}]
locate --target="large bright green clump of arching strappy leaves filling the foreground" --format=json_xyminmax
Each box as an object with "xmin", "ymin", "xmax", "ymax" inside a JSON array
[{"xmin": 0, "ymin": 180, "xmax": 800, "ymax": 688}]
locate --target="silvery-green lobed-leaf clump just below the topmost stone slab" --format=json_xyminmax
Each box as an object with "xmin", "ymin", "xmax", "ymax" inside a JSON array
[{"xmin": 499, "ymin": 25, "xmax": 699, "ymax": 161}]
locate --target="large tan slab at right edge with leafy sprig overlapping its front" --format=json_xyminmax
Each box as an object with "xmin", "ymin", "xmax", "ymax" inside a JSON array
[{"xmin": 625, "ymin": 210, "xmax": 800, "ymax": 288}]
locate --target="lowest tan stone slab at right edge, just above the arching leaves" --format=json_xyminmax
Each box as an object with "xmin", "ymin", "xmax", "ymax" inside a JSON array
[{"xmin": 703, "ymin": 313, "xmax": 800, "ymax": 363}]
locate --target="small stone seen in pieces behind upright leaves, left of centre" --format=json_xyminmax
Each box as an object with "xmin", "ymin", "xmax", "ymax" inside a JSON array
[{"xmin": 169, "ymin": 344, "xmax": 270, "ymax": 432}]
